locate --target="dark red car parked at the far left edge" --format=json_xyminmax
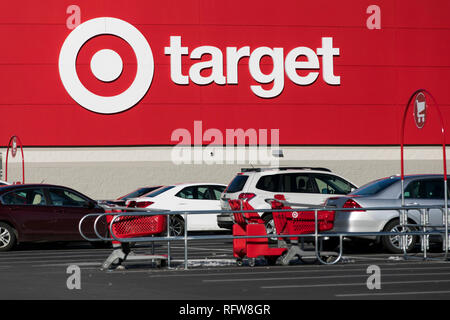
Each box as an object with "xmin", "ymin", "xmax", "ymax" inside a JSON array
[{"xmin": 0, "ymin": 184, "xmax": 106, "ymax": 251}]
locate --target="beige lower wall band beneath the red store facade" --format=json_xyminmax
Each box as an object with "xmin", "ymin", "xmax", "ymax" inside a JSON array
[{"xmin": 0, "ymin": 147, "xmax": 448, "ymax": 199}]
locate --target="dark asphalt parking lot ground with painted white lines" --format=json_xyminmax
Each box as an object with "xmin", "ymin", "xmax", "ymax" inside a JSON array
[{"xmin": 0, "ymin": 240, "xmax": 450, "ymax": 300}]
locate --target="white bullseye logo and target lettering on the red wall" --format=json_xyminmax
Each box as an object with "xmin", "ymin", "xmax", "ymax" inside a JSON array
[{"xmin": 58, "ymin": 17, "xmax": 341, "ymax": 114}]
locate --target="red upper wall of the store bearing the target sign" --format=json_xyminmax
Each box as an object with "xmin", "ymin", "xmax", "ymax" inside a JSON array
[{"xmin": 0, "ymin": 0, "xmax": 450, "ymax": 147}]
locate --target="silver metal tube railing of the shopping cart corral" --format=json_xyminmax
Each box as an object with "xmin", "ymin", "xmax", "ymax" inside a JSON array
[{"xmin": 79, "ymin": 200, "xmax": 449, "ymax": 269}]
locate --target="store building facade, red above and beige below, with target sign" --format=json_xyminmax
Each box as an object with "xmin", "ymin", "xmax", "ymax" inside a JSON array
[{"xmin": 0, "ymin": 0, "xmax": 450, "ymax": 199}]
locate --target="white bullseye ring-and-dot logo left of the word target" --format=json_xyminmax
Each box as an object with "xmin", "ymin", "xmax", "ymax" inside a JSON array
[{"xmin": 58, "ymin": 17, "xmax": 154, "ymax": 114}]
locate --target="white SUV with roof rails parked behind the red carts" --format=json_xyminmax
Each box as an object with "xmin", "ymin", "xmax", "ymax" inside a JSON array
[{"xmin": 217, "ymin": 167, "xmax": 357, "ymax": 234}]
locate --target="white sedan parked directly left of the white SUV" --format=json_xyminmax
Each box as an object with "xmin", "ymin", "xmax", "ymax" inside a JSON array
[{"xmin": 126, "ymin": 183, "xmax": 227, "ymax": 235}]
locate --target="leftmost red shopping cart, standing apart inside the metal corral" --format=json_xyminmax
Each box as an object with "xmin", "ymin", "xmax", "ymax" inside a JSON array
[{"xmin": 102, "ymin": 210, "xmax": 167, "ymax": 269}]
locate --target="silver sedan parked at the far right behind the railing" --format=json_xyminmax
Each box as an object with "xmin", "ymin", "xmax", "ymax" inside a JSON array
[{"xmin": 325, "ymin": 174, "xmax": 444, "ymax": 253}]
